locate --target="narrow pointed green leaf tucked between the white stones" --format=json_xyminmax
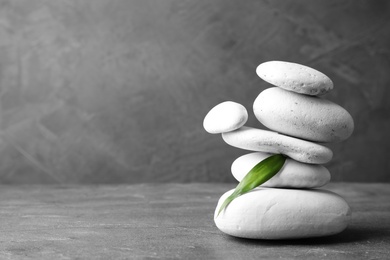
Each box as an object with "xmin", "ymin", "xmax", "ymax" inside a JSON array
[{"xmin": 217, "ymin": 154, "xmax": 286, "ymax": 217}]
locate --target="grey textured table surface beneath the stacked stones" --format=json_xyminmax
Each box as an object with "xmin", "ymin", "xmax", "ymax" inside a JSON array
[{"xmin": 0, "ymin": 183, "xmax": 390, "ymax": 259}]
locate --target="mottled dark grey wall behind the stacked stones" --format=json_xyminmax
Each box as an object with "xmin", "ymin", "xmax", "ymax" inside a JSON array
[{"xmin": 0, "ymin": 0, "xmax": 390, "ymax": 183}]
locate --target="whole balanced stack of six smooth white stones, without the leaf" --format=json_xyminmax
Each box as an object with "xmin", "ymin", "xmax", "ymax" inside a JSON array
[{"xmin": 204, "ymin": 61, "xmax": 354, "ymax": 239}]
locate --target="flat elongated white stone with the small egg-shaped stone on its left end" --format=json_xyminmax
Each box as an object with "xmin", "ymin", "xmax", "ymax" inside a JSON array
[{"xmin": 222, "ymin": 126, "xmax": 333, "ymax": 164}]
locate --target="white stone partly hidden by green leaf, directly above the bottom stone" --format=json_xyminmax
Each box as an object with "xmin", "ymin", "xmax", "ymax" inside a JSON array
[{"xmin": 231, "ymin": 152, "xmax": 330, "ymax": 188}]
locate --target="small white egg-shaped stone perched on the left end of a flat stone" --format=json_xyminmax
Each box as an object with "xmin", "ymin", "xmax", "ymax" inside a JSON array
[{"xmin": 203, "ymin": 101, "xmax": 248, "ymax": 134}]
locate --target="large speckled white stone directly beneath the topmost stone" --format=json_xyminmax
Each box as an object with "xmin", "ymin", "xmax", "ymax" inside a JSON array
[{"xmin": 253, "ymin": 87, "xmax": 354, "ymax": 142}]
